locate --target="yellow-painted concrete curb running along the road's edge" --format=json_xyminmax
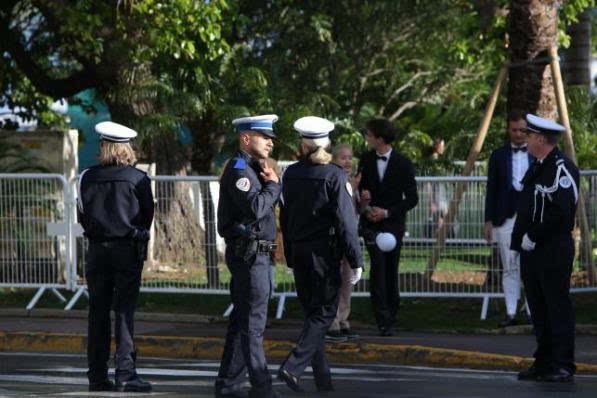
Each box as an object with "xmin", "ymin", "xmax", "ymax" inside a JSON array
[{"xmin": 0, "ymin": 332, "xmax": 597, "ymax": 375}]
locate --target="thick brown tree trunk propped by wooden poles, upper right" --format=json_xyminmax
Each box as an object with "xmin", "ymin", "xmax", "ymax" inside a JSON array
[{"xmin": 508, "ymin": 0, "xmax": 558, "ymax": 120}]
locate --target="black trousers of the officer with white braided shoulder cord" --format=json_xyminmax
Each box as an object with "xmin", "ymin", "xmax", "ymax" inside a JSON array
[{"xmin": 520, "ymin": 235, "xmax": 576, "ymax": 372}]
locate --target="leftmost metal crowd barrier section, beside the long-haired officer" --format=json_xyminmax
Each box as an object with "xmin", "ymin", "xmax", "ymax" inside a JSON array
[{"xmin": 0, "ymin": 174, "xmax": 72, "ymax": 310}]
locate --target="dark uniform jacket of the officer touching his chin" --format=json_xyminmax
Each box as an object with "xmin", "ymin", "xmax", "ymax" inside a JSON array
[{"xmin": 218, "ymin": 151, "xmax": 281, "ymax": 239}]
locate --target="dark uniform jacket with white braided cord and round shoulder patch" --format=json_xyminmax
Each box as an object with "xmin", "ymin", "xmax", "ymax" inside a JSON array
[{"xmin": 511, "ymin": 148, "xmax": 579, "ymax": 251}]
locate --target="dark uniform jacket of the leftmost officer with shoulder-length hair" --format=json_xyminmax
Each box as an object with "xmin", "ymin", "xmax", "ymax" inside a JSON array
[{"xmin": 78, "ymin": 165, "xmax": 154, "ymax": 241}]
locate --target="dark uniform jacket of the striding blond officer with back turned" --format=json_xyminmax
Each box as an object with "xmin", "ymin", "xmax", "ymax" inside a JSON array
[{"xmin": 280, "ymin": 158, "xmax": 363, "ymax": 268}]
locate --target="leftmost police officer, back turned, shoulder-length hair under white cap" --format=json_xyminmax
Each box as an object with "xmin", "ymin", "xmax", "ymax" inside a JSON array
[{"xmin": 78, "ymin": 122, "xmax": 154, "ymax": 392}]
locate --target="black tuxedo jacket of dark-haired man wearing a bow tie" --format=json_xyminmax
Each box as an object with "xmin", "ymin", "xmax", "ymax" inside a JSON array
[{"xmin": 359, "ymin": 149, "xmax": 419, "ymax": 238}]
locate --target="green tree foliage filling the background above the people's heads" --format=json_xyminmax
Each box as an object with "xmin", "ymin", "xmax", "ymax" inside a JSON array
[{"xmin": 0, "ymin": 0, "xmax": 597, "ymax": 173}]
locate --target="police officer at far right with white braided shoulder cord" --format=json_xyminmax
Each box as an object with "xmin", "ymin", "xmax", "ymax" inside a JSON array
[{"xmin": 511, "ymin": 114, "xmax": 579, "ymax": 382}]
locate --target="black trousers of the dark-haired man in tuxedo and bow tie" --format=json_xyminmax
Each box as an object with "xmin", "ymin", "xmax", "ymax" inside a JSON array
[{"xmin": 367, "ymin": 236, "xmax": 402, "ymax": 329}]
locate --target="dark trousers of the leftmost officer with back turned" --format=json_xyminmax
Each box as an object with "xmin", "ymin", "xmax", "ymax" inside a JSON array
[{"xmin": 85, "ymin": 241, "xmax": 143, "ymax": 383}]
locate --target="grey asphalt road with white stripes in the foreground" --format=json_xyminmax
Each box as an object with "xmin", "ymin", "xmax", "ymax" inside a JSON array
[{"xmin": 0, "ymin": 353, "xmax": 597, "ymax": 398}]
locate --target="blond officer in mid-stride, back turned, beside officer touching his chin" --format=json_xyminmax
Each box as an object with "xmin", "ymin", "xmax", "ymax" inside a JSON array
[{"xmin": 278, "ymin": 116, "xmax": 363, "ymax": 392}]
